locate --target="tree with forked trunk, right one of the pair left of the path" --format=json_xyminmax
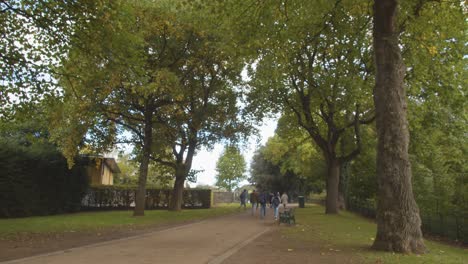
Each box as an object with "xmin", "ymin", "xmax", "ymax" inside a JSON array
[{"xmin": 151, "ymin": 28, "xmax": 245, "ymax": 210}]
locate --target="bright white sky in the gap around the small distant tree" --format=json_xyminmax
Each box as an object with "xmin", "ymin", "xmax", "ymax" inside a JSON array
[{"xmin": 190, "ymin": 116, "xmax": 278, "ymax": 186}]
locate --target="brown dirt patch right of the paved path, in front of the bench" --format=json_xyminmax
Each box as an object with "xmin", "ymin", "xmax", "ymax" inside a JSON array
[{"xmin": 223, "ymin": 227, "xmax": 362, "ymax": 264}]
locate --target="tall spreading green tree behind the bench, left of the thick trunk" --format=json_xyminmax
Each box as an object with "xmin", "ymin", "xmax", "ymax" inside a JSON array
[{"xmin": 245, "ymin": 1, "xmax": 374, "ymax": 214}]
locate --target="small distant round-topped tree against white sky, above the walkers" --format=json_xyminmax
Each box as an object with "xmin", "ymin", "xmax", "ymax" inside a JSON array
[{"xmin": 216, "ymin": 146, "xmax": 247, "ymax": 192}]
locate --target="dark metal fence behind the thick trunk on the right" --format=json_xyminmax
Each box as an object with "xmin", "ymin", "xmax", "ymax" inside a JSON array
[{"xmin": 347, "ymin": 199, "xmax": 468, "ymax": 245}]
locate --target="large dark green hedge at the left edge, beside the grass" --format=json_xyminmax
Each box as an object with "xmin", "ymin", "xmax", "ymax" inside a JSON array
[{"xmin": 0, "ymin": 142, "xmax": 88, "ymax": 217}]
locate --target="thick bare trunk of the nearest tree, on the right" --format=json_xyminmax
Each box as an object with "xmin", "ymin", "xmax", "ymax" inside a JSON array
[{"xmin": 372, "ymin": 0, "xmax": 425, "ymax": 253}]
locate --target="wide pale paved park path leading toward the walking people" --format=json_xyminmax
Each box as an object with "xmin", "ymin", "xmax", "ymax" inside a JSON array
[{"xmin": 2, "ymin": 210, "xmax": 276, "ymax": 264}]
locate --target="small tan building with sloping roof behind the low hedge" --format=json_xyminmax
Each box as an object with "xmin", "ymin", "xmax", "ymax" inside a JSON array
[{"xmin": 86, "ymin": 157, "xmax": 120, "ymax": 185}]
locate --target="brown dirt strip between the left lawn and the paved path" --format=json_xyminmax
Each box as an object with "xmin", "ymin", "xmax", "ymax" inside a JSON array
[{"xmin": 0, "ymin": 221, "xmax": 198, "ymax": 261}]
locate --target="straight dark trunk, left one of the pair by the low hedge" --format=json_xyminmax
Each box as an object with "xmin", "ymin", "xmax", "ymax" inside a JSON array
[{"xmin": 133, "ymin": 110, "xmax": 153, "ymax": 216}]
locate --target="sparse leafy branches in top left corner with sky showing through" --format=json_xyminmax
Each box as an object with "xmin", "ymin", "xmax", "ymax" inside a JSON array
[{"xmin": 0, "ymin": 0, "xmax": 109, "ymax": 118}]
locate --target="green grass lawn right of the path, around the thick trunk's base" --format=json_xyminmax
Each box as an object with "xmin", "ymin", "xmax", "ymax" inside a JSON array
[{"xmin": 282, "ymin": 204, "xmax": 468, "ymax": 264}]
